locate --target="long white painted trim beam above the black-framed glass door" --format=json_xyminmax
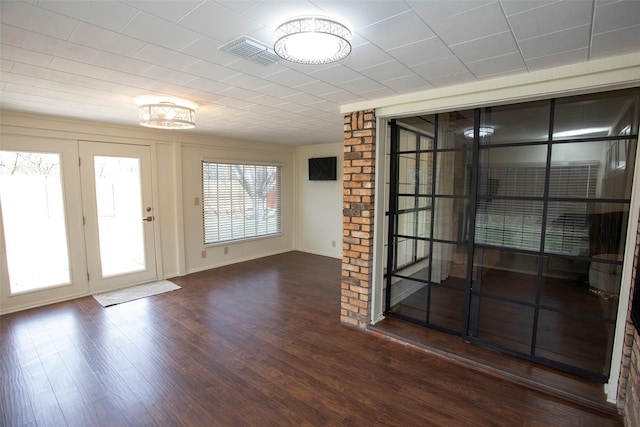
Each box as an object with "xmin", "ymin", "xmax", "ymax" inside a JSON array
[{"xmin": 340, "ymin": 53, "xmax": 640, "ymax": 117}]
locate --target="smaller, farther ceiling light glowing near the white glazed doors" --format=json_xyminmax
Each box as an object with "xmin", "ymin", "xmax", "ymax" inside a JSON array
[{"xmin": 137, "ymin": 97, "xmax": 196, "ymax": 129}]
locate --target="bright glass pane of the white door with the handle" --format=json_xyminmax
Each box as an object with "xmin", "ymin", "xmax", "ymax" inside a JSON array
[{"xmin": 94, "ymin": 156, "xmax": 146, "ymax": 277}]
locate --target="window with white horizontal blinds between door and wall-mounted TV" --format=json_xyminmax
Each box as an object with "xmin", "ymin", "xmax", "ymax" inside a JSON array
[{"xmin": 202, "ymin": 161, "xmax": 282, "ymax": 245}]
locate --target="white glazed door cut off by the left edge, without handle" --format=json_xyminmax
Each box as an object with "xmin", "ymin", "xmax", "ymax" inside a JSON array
[{"xmin": 0, "ymin": 135, "xmax": 87, "ymax": 314}]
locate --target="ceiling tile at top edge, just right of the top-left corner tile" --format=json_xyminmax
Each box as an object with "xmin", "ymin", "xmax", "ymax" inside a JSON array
[{"xmin": 38, "ymin": 0, "xmax": 138, "ymax": 31}]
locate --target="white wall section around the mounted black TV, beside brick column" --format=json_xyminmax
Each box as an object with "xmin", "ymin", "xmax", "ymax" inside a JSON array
[{"xmin": 296, "ymin": 142, "xmax": 344, "ymax": 258}]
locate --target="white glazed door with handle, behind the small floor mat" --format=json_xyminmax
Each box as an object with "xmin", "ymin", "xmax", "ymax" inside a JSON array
[{"xmin": 80, "ymin": 141, "xmax": 157, "ymax": 293}]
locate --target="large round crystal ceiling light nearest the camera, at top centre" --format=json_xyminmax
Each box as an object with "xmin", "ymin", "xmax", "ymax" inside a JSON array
[{"xmin": 273, "ymin": 16, "xmax": 351, "ymax": 65}]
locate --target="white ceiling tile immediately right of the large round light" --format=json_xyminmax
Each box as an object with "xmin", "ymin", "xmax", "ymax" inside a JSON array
[{"xmin": 358, "ymin": 11, "xmax": 434, "ymax": 49}]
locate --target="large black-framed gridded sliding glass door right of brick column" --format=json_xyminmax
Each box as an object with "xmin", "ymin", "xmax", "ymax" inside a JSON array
[{"xmin": 386, "ymin": 90, "xmax": 639, "ymax": 382}]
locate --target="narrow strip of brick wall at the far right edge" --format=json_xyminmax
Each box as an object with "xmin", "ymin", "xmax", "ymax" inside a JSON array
[{"xmin": 618, "ymin": 219, "xmax": 640, "ymax": 426}]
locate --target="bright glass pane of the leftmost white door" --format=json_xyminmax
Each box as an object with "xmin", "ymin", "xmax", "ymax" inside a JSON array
[{"xmin": 0, "ymin": 151, "xmax": 71, "ymax": 294}]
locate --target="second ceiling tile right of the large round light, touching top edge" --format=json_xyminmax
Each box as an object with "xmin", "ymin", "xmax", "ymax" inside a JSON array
[{"xmin": 429, "ymin": 3, "xmax": 510, "ymax": 45}]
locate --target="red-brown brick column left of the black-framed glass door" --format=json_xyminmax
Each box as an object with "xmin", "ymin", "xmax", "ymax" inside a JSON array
[{"xmin": 340, "ymin": 110, "xmax": 376, "ymax": 329}]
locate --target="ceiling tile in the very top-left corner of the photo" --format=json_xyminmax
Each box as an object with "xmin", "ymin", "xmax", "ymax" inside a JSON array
[{"xmin": 0, "ymin": 1, "xmax": 78, "ymax": 40}]
